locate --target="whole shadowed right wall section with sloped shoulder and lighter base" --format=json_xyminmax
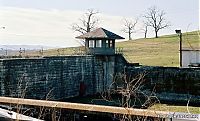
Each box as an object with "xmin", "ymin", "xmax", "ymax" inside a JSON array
[{"xmin": 115, "ymin": 55, "xmax": 200, "ymax": 104}]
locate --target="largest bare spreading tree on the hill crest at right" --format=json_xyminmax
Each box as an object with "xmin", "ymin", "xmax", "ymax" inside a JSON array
[{"xmin": 144, "ymin": 6, "xmax": 170, "ymax": 38}]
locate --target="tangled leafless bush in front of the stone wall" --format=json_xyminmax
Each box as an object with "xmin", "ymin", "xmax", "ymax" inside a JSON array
[{"xmin": 101, "ymin": 73, "xmax": 159, "ymax": 121}]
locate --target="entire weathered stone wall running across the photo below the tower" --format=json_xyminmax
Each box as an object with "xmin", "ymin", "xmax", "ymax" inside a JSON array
[{"xmin": 0, "ymin": 54, "xmax": 200, "ymax": 102}]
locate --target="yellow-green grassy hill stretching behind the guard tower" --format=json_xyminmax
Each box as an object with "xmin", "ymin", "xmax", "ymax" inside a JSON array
[{"xmin": 28, "ymin": 31, "xmax": 200, "ymax": 66}]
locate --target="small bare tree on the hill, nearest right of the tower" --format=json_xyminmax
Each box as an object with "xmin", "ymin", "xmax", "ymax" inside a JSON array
[{"xmin": 122, "ymin": 19, "xmax": 138, "ymax": 40}]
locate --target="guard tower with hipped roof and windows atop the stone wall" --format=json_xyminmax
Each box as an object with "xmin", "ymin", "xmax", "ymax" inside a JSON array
[{"xmin": 76, "ymin": 28, "xmax": 124, "ymax": 55}]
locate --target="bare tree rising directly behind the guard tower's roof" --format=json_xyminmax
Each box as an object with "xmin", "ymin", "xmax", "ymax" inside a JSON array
[{"xmin": 72, "ymin": 9, "xmax": 99, "ymax": 34}]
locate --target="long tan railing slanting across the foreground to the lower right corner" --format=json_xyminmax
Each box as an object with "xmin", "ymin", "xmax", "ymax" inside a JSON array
[{"xmin": 0, "ymin": 97, "xmax": 200, "ymax": 121}]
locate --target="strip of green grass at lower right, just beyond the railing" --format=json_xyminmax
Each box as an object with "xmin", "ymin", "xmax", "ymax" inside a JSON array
[{"xmin": 149, "ymin": 104, "xmax": 200, "ymax": 114}]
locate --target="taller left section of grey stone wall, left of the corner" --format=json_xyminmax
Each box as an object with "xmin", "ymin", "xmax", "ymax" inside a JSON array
[{"xmin": 0, "ymin": 56, "xmax": 114, "ymax": 99}]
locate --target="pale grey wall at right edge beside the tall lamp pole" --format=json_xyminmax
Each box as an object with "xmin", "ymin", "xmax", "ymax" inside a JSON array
[{"xmin": 182, "ymin": 50, "xmax": 200, "ymax": 67}]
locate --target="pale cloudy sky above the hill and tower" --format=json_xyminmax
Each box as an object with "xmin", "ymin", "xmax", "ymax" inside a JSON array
[{"xmin": 0, "ymin": 0, "xmax": 199, "ymax": 47}]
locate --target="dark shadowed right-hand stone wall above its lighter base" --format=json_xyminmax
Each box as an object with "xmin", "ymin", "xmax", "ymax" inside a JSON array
[{"xmin": 126, "ymin": 66, "xmax": 200, "ymax": 95}]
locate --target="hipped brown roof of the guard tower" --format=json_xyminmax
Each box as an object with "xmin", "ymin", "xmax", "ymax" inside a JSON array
[{"xmin": 76, "ymin": 28, "xmax": 125, "ymax": 39}]
